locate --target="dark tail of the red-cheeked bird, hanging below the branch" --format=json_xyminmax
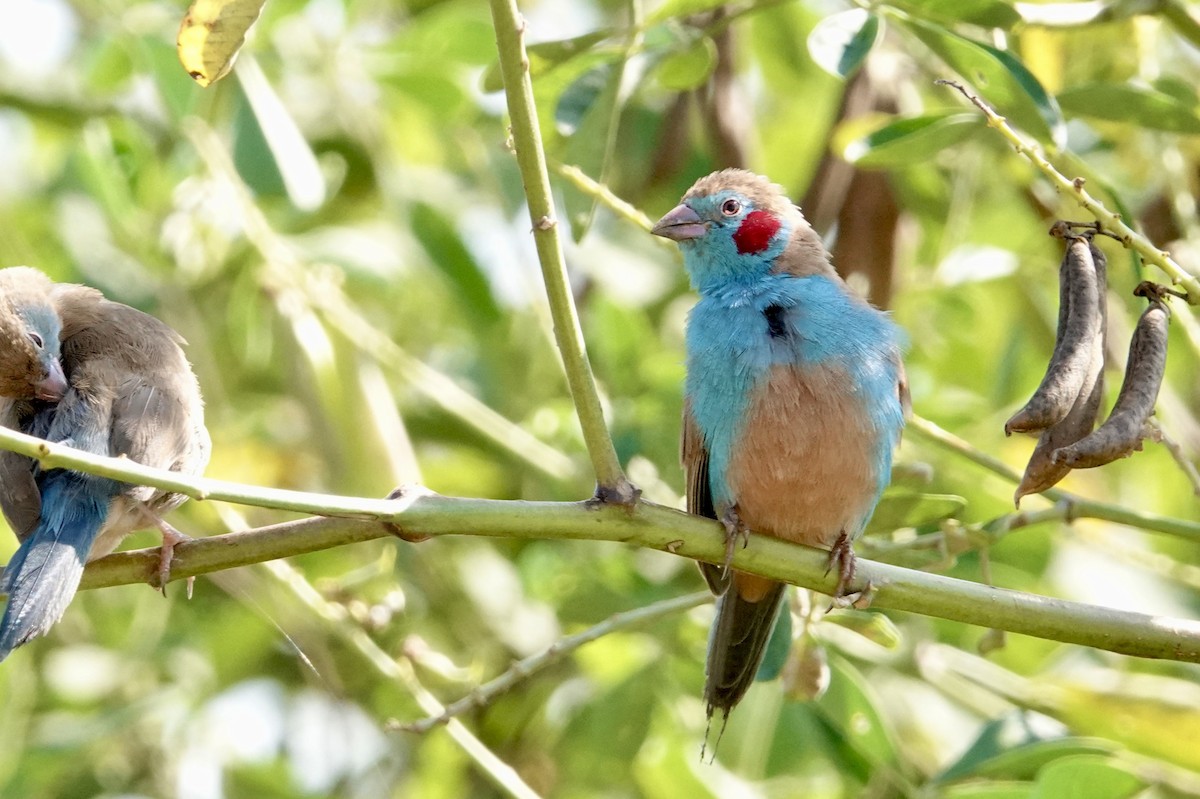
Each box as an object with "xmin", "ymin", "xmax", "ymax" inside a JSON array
[{"xmin": 704, "ymin": 573, "xmax": 785, "ymax": 740}]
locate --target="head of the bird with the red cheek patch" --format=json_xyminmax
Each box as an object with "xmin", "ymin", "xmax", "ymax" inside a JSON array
[{"xmin": 652, "ymin": 169, "xmax": 834, "ymax": 293}]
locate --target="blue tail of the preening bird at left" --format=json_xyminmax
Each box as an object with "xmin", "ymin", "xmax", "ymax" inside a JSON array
[{"xmin": 0, "ymin": 471, "xmax": 112, "ymax": 660}]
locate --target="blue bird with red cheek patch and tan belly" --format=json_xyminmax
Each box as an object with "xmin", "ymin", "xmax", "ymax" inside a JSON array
[{"xmin": 653, "ymin": 169, "xmax": 907, "ymax": 720}]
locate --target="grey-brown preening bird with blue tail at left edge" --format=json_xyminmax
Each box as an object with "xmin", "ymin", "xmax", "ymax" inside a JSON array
[{"xmin": 0, "ymin": 266, "xmax": 210, "ymax": 660}]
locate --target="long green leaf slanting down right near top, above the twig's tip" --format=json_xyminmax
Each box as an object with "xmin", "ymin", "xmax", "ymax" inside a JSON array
[{"xmin": 905, "ymin": 19, "xmax": 1066, "ymax": 146}]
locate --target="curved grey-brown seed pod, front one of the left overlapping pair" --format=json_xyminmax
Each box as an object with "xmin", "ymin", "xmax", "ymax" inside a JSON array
[{"xmin": 1004, "ymin": 224, "xmax": 1104, "ymax": 435}]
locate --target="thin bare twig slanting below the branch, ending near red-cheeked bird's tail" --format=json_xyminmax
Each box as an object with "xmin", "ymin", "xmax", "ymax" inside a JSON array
[{"xmin": 388, "ymin": 591, "xmax": 713, "ymax": 734}]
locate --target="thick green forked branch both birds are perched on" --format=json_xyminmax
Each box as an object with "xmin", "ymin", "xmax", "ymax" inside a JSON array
[{"xmin": 0, "ymin": 419, "xmax": 1200, "ymax": 662}]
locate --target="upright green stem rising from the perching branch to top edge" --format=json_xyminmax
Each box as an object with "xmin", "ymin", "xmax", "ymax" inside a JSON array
[{"xmin": 491, "ymin": 0, "xmax": 637, "ymax": 504}]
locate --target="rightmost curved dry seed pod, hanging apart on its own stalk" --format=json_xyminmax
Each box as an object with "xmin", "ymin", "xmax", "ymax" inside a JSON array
[{"xmin": 1054, "ymin": 289, "xmax": 1170, "ymax": 469}]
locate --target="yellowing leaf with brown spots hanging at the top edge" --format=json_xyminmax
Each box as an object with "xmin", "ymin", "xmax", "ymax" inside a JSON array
[{"xmin": 175, "ymin": 0, "xmax": 266, "ymax": 86}]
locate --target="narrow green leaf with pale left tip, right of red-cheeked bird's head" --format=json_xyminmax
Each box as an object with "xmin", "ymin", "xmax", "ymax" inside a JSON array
[{"xmin": 842, "ymin": 113, "xmax": 983, "ymax": 169}]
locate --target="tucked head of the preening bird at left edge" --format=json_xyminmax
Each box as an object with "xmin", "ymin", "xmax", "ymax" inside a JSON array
[{"xmin": 0, "ymin": 266, "xmax": 68, "ymax": 402}]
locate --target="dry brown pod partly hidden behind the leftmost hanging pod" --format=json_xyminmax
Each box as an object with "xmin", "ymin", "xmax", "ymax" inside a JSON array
[{"xmin": 1013, "ymin": 233, "xmax": 1108, "ymax": 507}]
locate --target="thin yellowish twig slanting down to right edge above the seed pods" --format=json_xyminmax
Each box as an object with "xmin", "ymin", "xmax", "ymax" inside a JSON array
[{"xmin": 934, "ymin": 79, "xmax": 1200, "ymax": 305}]
